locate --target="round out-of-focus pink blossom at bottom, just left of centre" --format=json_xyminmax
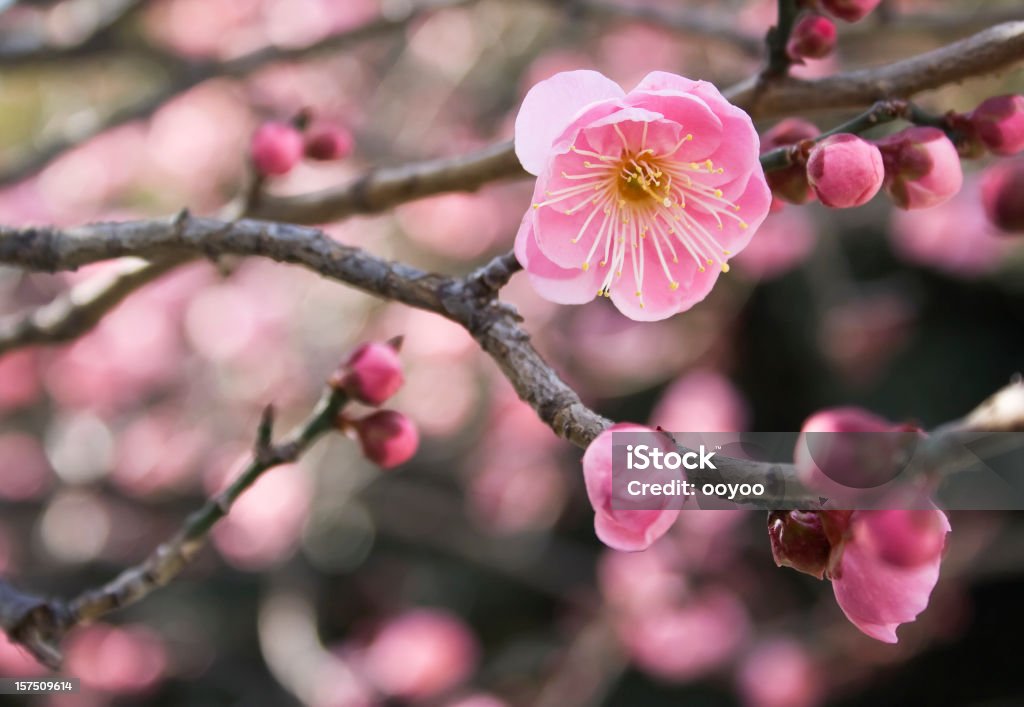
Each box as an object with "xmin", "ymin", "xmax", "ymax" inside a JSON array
[{"xmin": 364, "ymin": 609, "xmax": 479, "ymax": 700}]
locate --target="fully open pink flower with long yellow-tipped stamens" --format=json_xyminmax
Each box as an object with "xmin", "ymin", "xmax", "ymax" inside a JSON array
[{"xmin": 515, "ymin": 71, "xmax": 771, "ymax": 321}]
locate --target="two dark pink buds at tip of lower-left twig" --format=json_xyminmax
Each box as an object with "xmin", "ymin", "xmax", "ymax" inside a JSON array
[{"xmin": 329, "ymin": 337, "xmax": 420, "ymax": 469}]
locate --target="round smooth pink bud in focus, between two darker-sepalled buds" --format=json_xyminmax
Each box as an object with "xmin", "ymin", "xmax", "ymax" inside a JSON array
[{"xmin": 807, "ymin": 133, "xmax": 885, "ymax": 209}]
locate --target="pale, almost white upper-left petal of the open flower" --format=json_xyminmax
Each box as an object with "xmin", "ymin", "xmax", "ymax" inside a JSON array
[{"xmin": 515, "ymin": 71, "xmax": 624, "ymax": 174}]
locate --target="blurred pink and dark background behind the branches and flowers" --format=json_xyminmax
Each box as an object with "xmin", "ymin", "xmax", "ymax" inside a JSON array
[{"xmin": 0, "ymin": 0, "xmax": 1024, "ymax": 707}]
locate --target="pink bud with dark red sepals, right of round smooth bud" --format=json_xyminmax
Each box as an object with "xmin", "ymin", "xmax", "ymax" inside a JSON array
[{"xmin": 876, "ymin": 126, "xmax": 964, "ymax": 210}]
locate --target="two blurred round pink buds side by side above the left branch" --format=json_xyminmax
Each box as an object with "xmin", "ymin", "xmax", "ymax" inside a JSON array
[{"xmin": 249, "ymin": 115, "xmax": 353, "ymax": 176}]
